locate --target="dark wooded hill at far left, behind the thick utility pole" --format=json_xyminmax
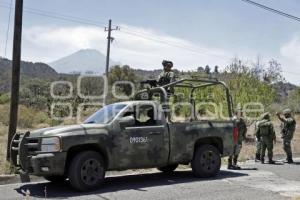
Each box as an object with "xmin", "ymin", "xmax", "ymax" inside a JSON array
[{"xmin": 0, "ymin": 57, "xmax": 59, "ymax": 92}]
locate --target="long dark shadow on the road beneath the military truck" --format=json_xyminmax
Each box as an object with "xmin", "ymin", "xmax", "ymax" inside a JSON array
[{"xmin": 15, "ymin": 171, "xmax": 247, "ymax": 198}]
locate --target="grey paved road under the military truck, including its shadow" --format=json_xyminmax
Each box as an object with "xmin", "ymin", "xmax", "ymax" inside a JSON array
[{"xmin": 0, "ymin": 159, "xmax": 300, "ymax": 200}]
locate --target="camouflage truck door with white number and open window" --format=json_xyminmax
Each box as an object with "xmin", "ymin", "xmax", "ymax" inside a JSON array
[{"xmin": 113, "ymin": 105, "xmax": 169, "ymax": 168}]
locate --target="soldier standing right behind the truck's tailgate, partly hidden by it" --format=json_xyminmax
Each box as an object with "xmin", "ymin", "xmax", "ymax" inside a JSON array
[{"xmin": 227, "ymin": 109, "xmax": 247, "ymax": 169}]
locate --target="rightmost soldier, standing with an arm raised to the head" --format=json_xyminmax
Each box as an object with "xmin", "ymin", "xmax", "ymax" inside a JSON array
[{"xmin": 276, "ymin": 109, "xmax": 296, "ymax": 163}]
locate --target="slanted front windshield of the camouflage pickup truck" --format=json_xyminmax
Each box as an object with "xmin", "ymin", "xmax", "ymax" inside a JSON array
[{"xmin": 83, "ymin": 104, "xmax": 126, "ymax": 124}]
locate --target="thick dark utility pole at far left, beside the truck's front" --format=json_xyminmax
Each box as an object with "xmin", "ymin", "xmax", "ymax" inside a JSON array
[{"xmin": 6, "ymin": 0, "xmax": 23, "ymax": 161}]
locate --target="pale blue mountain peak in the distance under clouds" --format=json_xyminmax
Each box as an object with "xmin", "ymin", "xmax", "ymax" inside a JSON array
[{"xmin": 49, "ymin": 49, "xmax": 119, "ymax": 73}]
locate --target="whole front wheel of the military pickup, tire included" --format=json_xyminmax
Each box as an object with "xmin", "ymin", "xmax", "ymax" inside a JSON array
[{"xmin": 68, "ymin": 151, "xmax": 105, "ymax": 191}]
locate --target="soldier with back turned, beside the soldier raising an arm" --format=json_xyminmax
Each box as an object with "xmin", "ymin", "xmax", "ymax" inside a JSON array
[{"xmin": 255, "ymin": 113, "xmax": 276, "ymax": 164}]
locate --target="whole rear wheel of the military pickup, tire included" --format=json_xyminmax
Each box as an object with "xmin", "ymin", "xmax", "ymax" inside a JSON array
[{"xmin": 192, "ymin": 145, "xmax": 221, "ymax": 178}]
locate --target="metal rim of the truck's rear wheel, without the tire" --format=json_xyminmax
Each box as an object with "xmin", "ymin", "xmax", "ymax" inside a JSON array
[{"xmin": 200, "ymin": 151, "xmax": 218, "ymax": 173}]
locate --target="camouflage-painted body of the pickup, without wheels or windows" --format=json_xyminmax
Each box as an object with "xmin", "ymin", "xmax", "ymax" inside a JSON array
[{"xmin": 12, "ymin": 101, "xmax": 234, "ymax": 176}]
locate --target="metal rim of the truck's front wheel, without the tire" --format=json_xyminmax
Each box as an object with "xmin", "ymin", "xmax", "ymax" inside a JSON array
[{"xmin": 81, "ymin": 159, "xmax": 103, "ymax": 185}]
